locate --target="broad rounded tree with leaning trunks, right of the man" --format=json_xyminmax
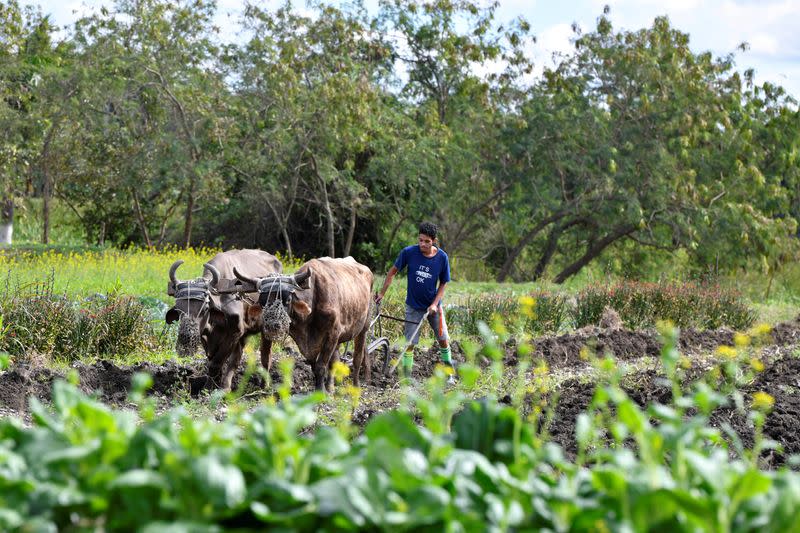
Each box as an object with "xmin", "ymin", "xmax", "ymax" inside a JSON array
[{"xmin": 499, "ymin": 11, "xmax": 800, "ymax": 283}]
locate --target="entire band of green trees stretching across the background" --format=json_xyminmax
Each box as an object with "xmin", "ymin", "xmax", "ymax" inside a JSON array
[{"xmin": 0, "ymin": 0, "xmax": 800, "ymax": 283}]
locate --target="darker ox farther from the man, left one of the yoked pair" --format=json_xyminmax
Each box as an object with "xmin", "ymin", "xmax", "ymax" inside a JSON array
[{"xmin": 165, "ymin": 250, "xmax": 283, "ymax": 390}]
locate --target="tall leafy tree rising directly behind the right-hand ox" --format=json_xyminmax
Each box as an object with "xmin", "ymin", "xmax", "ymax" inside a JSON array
[{"xmin": 229, "ymin": 0, "xmax": 396, "ymax": 257}]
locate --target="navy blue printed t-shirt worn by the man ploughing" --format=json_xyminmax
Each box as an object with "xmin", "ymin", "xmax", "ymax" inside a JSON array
[{"xmin": 394, "ymin": 244, "xmax": 450, "ymax": 309}]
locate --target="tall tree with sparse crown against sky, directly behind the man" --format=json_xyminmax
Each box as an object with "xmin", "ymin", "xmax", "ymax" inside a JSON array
[{"xmin": 380, "ymin": 0, "xmax": 532, "ymax": 259}]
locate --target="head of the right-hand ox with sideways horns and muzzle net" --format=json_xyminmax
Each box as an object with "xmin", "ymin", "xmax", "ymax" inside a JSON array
[{"xmin": 233, "ymin": 267, "xmax": 313, "ymax": 340}]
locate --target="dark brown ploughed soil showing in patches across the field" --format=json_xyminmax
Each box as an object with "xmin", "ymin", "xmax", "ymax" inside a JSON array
[{"xmin": 0, "ymin": 317, "xmax": 800, "ymax": 466}]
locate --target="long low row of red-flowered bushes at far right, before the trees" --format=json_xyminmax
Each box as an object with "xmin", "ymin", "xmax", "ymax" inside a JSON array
[{"xmin": 572, "ymin": 281, "xmax": 756, "ymax": 330}]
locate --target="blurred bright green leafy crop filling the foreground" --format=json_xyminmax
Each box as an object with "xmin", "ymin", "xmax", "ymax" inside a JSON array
[{"xmin": 0, "ymin": 318, "xmax": 800, "ymax": 532}]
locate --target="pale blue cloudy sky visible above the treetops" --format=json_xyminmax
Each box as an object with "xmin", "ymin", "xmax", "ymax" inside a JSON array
[{"xmin": 40, "ymin": 0, "xmax": 800, "ymax": 99}]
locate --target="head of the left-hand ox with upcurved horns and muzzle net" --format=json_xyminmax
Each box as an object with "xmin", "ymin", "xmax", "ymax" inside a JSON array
[{"xmin": 165, "ymin": 260, "xmax": 219, "ymax": 355}]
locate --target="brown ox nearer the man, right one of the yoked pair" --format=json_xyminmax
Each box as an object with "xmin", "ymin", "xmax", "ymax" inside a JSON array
[{"xmin": 234, "ymin": 257, "xmax": 372, "ymax": 392}]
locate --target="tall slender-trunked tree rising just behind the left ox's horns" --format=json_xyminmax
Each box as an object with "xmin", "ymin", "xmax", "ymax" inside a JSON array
[{"xmin": 70, "ymin": 0, "xmax": 230, "ymax": 246}]
